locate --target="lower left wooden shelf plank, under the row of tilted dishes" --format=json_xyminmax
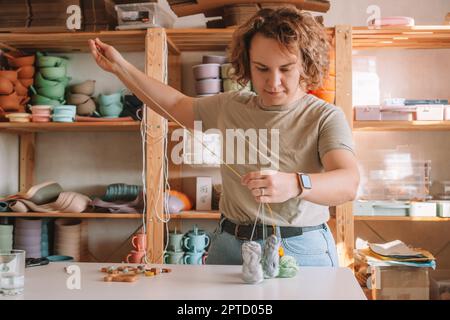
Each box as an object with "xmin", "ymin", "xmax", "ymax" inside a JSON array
[{"xmin": 0, "ymin": 212, "xmax": 142, "ymax": 219}]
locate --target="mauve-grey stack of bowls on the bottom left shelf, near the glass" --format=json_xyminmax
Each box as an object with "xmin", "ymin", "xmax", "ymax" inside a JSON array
[{"xmin": 14, "ymin": 218, "xmax": 42, "ymax": 258}]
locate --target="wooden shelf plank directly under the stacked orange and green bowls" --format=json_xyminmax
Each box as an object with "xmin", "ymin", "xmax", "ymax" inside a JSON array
[{"xmin": 0, "ymin": 121, "xmax": 140, "ymax": 133}]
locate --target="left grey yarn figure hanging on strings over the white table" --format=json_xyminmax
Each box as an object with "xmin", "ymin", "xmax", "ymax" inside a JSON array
[{"xmin": 242, "ymin": 241, "xmax": 264, "ymax": 284}]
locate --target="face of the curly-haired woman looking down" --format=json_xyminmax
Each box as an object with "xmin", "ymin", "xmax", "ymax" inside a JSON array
[{"xmin": 250, "ymin": 33, "xmax": 305, "ymax": 106}]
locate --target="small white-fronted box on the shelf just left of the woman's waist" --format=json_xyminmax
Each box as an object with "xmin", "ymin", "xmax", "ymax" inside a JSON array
[{"xmin": 183, "ymin": 177, "xmax": 212, "ymax": 210}]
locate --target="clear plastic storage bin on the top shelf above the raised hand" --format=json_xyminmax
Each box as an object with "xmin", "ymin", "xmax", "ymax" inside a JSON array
[{"xmin": 115, "ymin": 2, "xmax": 175, "ymax": 30}]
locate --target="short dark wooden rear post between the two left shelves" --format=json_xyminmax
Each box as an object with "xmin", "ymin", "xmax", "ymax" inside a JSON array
[{"xmin": 19, "ymin": 133, "xmax": 36, "ymax": 192}]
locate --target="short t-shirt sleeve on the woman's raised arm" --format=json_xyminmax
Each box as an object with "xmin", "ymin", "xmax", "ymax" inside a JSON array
[{"xmin": 193, "ymin": 93, "xmax": 224, "ymax": 131}]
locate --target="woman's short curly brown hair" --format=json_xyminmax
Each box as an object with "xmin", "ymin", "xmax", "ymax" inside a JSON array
[{"xmin": 230, "ymin": 7, "xmax": 330, "ymax": 90}]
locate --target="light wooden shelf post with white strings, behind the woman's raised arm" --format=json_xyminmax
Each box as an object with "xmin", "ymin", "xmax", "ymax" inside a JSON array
[{"xmin": 143, "ymin": 28, "xmax": 167, "ymax": 263}]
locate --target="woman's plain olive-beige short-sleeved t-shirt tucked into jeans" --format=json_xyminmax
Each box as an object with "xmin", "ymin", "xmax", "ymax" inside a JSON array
[{"xmin": 194, "ymin": 91, "xmax": 353, "ymax": 226}]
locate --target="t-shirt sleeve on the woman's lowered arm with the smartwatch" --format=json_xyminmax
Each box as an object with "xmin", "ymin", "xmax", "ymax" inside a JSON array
[{"xmin": 319, "ymin": 107, "xmax": 355, "ymax": 159}]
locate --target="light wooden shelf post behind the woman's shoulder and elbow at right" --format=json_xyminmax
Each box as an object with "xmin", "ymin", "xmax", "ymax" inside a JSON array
[{"xmin": 335, "ymin": 25, "xmax": 355, "ymax": 266}]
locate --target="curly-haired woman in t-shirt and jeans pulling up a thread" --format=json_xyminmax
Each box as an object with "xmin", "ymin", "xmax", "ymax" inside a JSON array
[{"xmin": 90, "ymin": 8, "xmax": 359, "ymax": 266}]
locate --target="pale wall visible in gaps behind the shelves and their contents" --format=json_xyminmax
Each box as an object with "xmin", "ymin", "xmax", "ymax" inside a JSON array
[{"xmin": 0, "ymin": 0, "xmax": 450, "ymax": 267}]
